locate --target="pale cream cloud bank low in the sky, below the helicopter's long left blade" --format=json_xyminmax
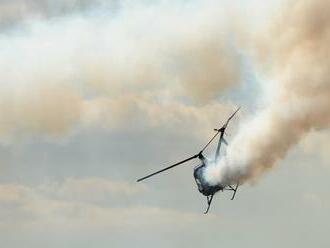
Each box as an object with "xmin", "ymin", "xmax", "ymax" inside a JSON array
[{"xmin": 0, "ymin": 178, "xmax": 211, "ymax": 230}]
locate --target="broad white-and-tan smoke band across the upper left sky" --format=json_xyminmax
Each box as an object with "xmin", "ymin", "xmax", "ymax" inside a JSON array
[{"xmin": 0, "ymin": 1, "xmax": 240, "ymax": 140}]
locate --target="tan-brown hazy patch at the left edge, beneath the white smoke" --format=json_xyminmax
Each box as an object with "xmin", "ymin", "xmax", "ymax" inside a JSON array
[{"xmin": 0, "ymin": 85, "xmax": 83, "ymax": 142}]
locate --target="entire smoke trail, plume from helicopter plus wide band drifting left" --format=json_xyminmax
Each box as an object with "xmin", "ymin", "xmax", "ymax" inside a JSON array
[{"xmin": 0, "ymin": 0, "xmax": 330, "ymax": 188}]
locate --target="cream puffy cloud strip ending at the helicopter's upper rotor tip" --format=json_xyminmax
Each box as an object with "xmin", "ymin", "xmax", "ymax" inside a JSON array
[{"xmin": 84, "ymin": 92, "xmax": 234, "ymax": 138}]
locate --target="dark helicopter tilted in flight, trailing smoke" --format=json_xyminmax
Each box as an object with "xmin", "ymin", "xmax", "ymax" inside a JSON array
[{"xmin": 137, "ymin": 107, "xmax": 240, "ymax": 214}]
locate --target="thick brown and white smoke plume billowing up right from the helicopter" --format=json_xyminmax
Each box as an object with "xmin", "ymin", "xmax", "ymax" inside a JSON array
[{"xmin": 207, "ymin": 0, "xmax": 330, "ymax": 186}]
